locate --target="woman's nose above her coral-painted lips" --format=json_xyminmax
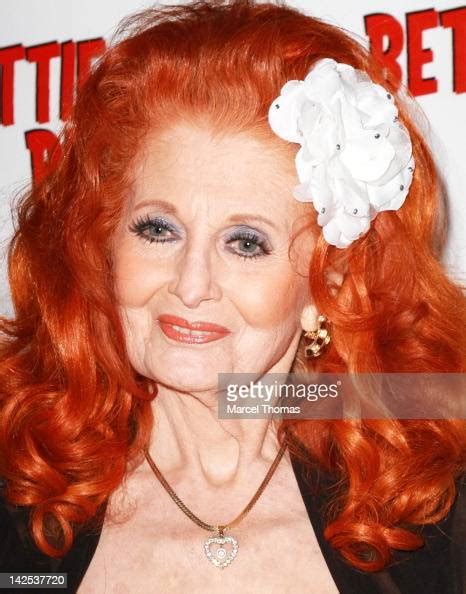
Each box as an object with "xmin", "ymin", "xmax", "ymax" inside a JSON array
[{"xmin": 168, "ymin": 240, "xmax": 222, "ymax": 309}]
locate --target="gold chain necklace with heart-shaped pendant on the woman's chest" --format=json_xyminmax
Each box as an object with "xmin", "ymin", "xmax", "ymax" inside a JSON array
[{"xmin": 144, "ymin": 439, "xmax": 287, "ymax": 569}]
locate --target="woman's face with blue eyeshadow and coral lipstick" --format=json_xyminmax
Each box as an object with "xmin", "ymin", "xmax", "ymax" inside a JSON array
[{"xmin": 113, "ymin": 124, "xmax": 311, "ymax": 391}]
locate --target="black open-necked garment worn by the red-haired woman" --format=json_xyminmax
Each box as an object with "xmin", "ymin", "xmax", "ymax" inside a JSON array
[{"xmin": 0, "ymin": 456, "xmax": 466, "ymax": 594}]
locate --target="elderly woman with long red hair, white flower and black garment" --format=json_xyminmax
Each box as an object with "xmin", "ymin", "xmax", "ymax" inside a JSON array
[{"xmin": 0, "ymin": 0, "xmax": 466, "ymax": 594}]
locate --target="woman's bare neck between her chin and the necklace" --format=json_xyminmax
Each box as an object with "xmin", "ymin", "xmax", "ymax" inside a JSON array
[{"xmin": 149, "ymin": 385, "xmax": 280, "ymax": 487}]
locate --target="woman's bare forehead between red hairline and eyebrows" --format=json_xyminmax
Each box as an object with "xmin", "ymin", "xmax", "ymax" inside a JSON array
[{"xmin": 125, "ymin": 128, "xmax": 309, "ymax": 231}]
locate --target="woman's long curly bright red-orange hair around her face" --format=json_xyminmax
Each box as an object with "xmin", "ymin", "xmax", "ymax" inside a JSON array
[{"xmin": 0, "ymin": 0, "xmax": 466, "ymax": 571}]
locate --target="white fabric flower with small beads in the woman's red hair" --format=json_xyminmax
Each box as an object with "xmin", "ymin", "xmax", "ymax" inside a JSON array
[{"xmin": 269, "ymin": 58, "xmax": 414, "ymax": 248}]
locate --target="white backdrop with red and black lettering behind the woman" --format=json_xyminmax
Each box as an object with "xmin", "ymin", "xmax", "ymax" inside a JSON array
[{"xmin": 0, "ymin": 0, "xmax": 466, "ymax": 315}]
